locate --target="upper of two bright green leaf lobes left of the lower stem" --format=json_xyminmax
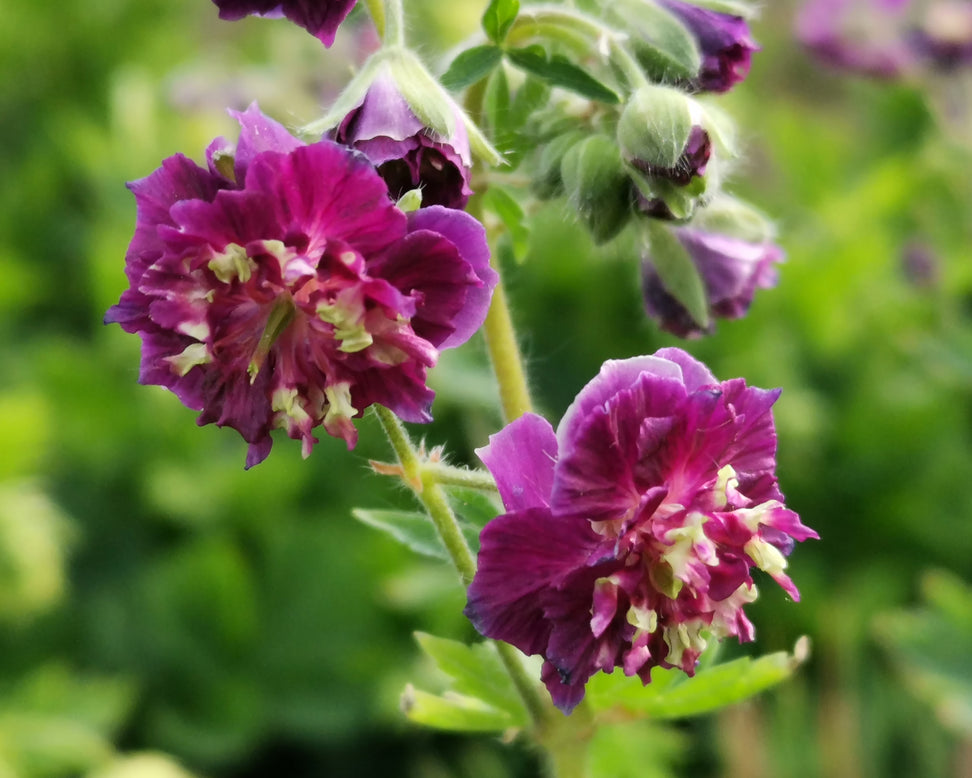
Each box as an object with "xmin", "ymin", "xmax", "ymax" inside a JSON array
[{"xmin": 415, "ymin": 632, "xmax": 527, "ymax": 725}]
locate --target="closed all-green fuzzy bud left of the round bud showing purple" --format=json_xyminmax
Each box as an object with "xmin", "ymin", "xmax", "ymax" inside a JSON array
[{"xmin": 560, "ymin": 135, "xmax": 631, "ymax": 243}]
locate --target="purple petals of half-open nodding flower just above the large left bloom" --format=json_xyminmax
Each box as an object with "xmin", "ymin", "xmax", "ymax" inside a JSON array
[{"xmin": 334, "ymin": 72, "xmax": 472, "ymax": 208}]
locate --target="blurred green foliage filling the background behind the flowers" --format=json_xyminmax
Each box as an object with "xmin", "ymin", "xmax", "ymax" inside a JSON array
[{"xmin": 0, "ymin": 0, "xmax": 972, "ymax": 778}]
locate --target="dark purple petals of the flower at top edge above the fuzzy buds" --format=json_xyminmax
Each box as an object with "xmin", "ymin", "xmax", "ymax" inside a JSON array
[{"xmin": 661, "ymin": 0, "xmax": 759, "ymax": 92}]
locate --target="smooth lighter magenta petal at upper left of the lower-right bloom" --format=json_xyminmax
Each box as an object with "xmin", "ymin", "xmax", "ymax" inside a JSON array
[{"xmin": 476, "ymin": 413, "xmax": 557, "ymax": 512}]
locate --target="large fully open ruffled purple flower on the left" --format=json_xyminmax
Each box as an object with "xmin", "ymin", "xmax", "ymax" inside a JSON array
[{"xmin": 105, "ymin": 106, "xmax": 496, "ymax": 467}]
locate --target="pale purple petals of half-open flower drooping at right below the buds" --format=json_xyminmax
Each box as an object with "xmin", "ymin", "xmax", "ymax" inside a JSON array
[{"xmin": 642, "ymin": 227, "xmax": 783, "ymax": 338}]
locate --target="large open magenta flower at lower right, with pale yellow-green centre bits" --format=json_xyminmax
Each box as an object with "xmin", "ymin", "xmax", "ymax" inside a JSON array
[{"xmin": 466, "ymin": 349, "xmax": 817, "ymax": 713}]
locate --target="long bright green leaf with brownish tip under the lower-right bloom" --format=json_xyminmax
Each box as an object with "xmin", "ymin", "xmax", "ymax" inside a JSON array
[{"xmin": 587, "ymin": 638, "xmax": 809, "ymax": 719}]
